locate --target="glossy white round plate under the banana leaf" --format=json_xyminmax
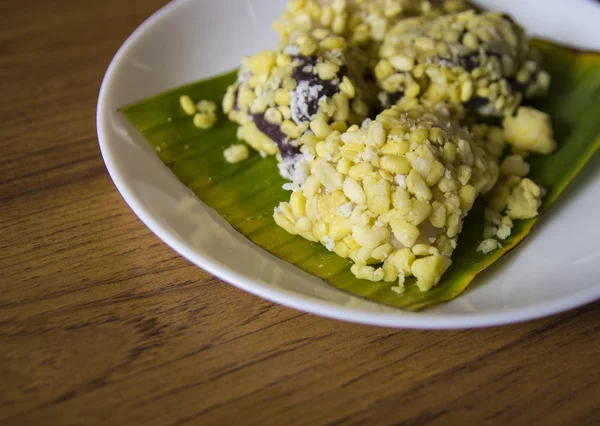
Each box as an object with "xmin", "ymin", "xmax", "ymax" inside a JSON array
[{"xmin": 97, "ymin": 0, "xmax": 600, "ymax": 328}]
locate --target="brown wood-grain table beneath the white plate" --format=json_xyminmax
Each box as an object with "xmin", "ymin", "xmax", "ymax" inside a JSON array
[{"xmin": 0, "ymin": 0, "xmax": 600, "ymax": 426}]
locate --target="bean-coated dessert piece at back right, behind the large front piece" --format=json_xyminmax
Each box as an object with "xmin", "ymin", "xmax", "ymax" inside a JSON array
[{"xmin": 375, "ymin": 10, "xmax": 550, "ymax": 118}]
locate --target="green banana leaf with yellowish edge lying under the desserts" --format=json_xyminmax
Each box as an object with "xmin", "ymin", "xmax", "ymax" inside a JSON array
[{"xmin": 120, "ymin": 40, "xmax": 600, "ymax": 310}]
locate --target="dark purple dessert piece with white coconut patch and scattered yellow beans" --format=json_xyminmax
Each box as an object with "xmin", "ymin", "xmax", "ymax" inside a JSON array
[{"xmin": 223, "ymin": 29, "xmax": 369, "ymax": 160}]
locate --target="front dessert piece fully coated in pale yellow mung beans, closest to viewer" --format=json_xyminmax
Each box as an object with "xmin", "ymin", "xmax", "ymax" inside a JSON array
[{"xmin": 274, "ymin": 105, "xmax": 499, "ymax": 291}]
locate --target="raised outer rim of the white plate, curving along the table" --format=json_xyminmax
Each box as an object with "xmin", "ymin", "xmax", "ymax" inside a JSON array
[{"xmin": 96, "ymin": 0, "xmax": 600, "ymax": 330}]
